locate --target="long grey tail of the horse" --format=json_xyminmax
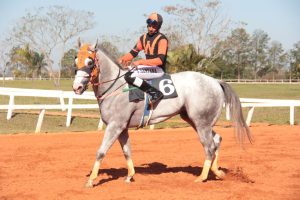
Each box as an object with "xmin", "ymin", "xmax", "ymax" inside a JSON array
[{"xmin": 219, "ymin": 81, "xmax": 253, "ymax": 144}]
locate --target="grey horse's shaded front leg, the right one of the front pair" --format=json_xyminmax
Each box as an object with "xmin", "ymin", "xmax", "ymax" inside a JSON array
[{"xmin": 118, "ymin": 129, "xmax": 135, "ymax": 183}]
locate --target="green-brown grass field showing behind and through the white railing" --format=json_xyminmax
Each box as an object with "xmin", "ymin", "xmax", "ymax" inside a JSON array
[{"xmin": 0, "ymin": 80, "xmax": 300, "ymax": 133}]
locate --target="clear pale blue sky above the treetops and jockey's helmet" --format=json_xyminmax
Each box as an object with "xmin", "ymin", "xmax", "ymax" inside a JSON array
[{"xmin": 0, "ymin": 0, "xmax": 300, "ymax": 49}]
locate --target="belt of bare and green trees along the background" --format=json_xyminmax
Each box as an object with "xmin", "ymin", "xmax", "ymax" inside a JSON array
[{"xmin": 0, "ymin": 3, "xmax": 300, "ymax": 81}]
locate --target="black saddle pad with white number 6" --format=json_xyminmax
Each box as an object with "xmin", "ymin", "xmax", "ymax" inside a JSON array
[{"xmin": 129, "ymin": 74, "xmax": 178, "ymax": 102}]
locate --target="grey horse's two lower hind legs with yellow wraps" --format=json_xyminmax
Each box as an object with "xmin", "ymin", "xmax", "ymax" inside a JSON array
[{"xmin": 195, "ymin": 127, "xmax": 223, "ymax": 182}]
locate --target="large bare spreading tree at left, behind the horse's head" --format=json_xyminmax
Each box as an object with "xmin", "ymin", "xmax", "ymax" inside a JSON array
[{"xmin": 10, "ymin": 6, "xmax": 94, "ymax": 86}]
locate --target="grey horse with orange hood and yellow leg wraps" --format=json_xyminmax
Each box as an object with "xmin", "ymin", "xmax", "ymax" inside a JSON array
[{"xmin": 73, "ymin": 40, "xmax": 252, "ymax": 187}]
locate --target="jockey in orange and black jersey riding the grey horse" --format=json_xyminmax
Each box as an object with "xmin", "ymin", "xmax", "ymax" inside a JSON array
[{"xmin": 119, "ymin": 13, "xmax": 168, "ymax": 105}]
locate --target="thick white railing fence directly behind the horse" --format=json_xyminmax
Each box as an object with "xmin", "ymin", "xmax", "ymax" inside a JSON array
[{"xmin": 0, "ymin": 87, "xmax": 300, "ymax": 133}]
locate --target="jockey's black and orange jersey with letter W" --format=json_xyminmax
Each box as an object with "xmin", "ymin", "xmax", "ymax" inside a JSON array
[{"xmin": 130, "ymin": 32, "xmax": 168, "ymax": 71}]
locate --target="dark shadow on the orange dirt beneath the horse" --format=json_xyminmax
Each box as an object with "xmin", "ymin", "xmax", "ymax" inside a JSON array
[{"xmin": 87, "ymin": 162, "xmax": 228, "ymax": 186}]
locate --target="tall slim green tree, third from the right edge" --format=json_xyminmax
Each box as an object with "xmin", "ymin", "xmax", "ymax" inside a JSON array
[{"xmin": 250, "ymin": 30, "xmax": 270, "ymax": 80}]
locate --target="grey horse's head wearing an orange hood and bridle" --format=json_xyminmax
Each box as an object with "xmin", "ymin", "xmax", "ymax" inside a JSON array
[{"xmin": 73, "ymin": 39, "xmax": 99, "ymax": 94}]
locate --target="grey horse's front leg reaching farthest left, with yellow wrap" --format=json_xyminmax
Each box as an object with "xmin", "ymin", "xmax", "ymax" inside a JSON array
[{"xmin": 86, "ymin": 123, "xmax": 124, "ymax": 188}]
